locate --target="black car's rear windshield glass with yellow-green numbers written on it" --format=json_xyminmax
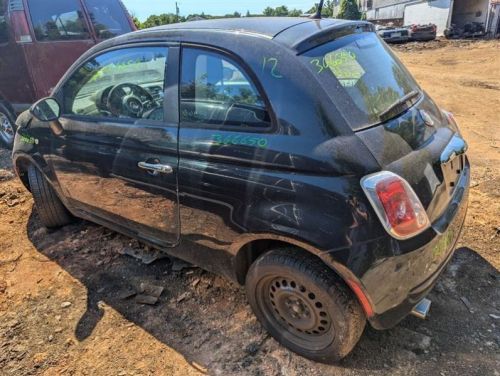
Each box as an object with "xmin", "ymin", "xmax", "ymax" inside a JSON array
[{"xmin": 302, "ymin": 33, "xmax": 420, "ymax": 130}]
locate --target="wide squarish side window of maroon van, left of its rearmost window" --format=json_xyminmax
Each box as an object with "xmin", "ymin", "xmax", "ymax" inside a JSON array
[{"xmin": 28, "ymin": 0, "xmax": 90, "ymax": 41}]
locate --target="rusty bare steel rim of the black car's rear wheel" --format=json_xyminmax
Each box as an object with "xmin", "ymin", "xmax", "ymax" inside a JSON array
[{"xmin": 257, "ymin": 276, "xmax": 335, "ymax": 350}]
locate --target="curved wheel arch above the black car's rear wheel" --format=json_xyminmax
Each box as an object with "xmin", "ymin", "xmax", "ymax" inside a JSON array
[{"xmin": 232, "ymin": 234, "xmax": 374, "ymax": 318}]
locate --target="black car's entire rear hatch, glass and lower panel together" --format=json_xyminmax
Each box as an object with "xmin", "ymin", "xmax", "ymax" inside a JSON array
[{"xmin": 301, "ymin": 30, "xmax": 466, "ymax": 223}]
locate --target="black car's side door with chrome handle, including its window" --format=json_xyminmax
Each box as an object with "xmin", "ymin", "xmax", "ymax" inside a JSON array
[{"xmin": 50, "ymin": 44, "xmax": 179, "ymax": 247}]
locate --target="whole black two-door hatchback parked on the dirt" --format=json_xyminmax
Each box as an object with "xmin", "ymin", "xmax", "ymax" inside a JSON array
[{"xmin": 13, "ymin": 18, "xmax": 470, "ymax": 362}]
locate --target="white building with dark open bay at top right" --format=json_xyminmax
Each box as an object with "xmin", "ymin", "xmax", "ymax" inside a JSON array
[{"xmin": 362, "ymin": 0, "xmax": 500, "ymax": 37}]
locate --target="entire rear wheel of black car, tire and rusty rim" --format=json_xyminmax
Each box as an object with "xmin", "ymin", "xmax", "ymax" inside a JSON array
[{"xmin": 246, "ymin": 248, "xmax": 366, "ymax": 363}]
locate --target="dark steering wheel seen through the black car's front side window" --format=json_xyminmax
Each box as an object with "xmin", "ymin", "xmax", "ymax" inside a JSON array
[{"xmin": 107, "ymin": 83, "xmax": 156, "ymax": 118}]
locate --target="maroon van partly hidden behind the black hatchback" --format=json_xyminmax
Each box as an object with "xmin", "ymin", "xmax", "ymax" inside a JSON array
[{"xmin": 0, "ymin": 0, "xmax": 136, "ymax": 147}]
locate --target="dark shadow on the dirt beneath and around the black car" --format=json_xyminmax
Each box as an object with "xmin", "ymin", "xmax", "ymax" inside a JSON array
[{"xmin": 27, "ymin": 212, "xmax": 500, "ymax": 375}]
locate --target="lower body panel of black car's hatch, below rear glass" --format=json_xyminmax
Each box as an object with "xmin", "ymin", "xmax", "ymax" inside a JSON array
[{"xmin": 357, "ymin": 95, "xmax": 467, "ymax": 222}]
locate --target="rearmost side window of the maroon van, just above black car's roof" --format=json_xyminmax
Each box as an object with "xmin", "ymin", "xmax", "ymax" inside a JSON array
[{"xmin": 85, "ymin": 0, "xmax": 132, "ymax": 39}]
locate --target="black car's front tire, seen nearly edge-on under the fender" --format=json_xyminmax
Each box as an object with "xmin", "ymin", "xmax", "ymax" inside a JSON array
[{"xmin": 28, "ymin": 165, "xmax": 72, "ymax": 228}]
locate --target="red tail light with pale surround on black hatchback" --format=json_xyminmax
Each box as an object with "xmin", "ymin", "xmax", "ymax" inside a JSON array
[{"xmin": 361, "ymin": 171, "xmax": 430, "ymax": 240}]
